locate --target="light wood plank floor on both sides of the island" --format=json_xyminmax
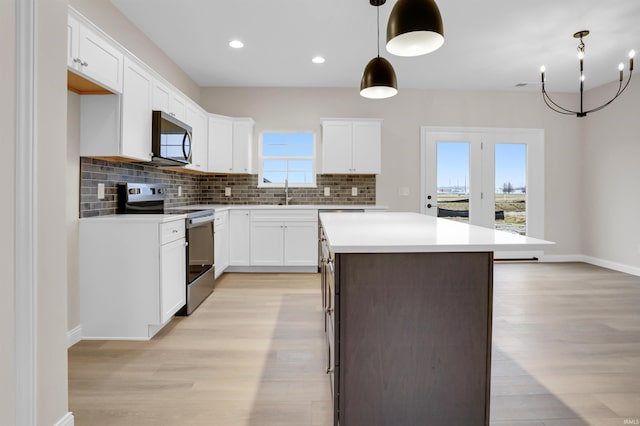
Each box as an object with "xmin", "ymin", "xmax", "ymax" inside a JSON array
[{"xmin": 69, "ymin": 263, "xmax": 640, "ymax": 426}]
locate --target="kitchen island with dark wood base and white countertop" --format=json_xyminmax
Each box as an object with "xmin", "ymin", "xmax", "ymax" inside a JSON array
[{"xmin": 320, "ymin": 213, "xmax": 553, "ymax": 426}]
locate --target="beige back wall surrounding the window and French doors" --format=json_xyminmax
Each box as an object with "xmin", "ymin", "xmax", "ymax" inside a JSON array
[{"xmin": 201, "ymin": 83, "xmax": 582, "ymax": 255}]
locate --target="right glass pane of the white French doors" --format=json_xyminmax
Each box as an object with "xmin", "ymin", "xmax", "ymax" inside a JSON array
[{"xmin": 495, "ymin": 143, "xmax": 527, "ymax": 235}]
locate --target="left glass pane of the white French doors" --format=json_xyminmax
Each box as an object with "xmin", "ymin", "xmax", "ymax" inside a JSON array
[{"xmin": 436, "ymin": 142, "xmax": 469, "ymax": 222}]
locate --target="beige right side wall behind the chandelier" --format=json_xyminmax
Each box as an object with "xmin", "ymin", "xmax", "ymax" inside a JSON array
[{"xmin": 580, "ymin": 80, "xmax": 640, "ymax": 271}]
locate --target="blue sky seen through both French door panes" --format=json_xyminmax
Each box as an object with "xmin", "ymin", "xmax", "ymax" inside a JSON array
[{"xmin": 437, "ymin": 142, "xmax": 527, "ymax": 193}]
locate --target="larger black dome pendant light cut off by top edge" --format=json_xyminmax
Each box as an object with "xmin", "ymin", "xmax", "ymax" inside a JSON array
[{"xmin": 387, "ymin": 0, "xmax": 444, "ymax": 56}]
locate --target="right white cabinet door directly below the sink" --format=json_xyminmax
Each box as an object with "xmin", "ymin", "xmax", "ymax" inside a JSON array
[{"xmin": 284, "ymin": 222, "xmax": 318, "ymax": 266}]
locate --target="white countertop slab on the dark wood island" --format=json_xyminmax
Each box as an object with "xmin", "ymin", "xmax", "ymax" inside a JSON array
[{"xmin": 320, "ymin": 212, "xmax": 555, "ymax": 253}]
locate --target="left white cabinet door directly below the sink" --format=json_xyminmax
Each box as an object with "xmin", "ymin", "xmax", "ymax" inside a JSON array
[{"xmin": 251, "ymin": 221, "xmax": 284, "ymax": 266}]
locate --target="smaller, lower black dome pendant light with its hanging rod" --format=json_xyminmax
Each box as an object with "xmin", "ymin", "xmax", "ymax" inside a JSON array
[{"xmin": 360, "ymin": 0, "xmax": 398, "ymax": 99}]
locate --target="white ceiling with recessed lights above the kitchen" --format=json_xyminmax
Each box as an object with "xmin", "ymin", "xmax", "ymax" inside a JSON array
[{"xmin": 111, "ymin": 0, "xmax": 640, "ymax": 92}]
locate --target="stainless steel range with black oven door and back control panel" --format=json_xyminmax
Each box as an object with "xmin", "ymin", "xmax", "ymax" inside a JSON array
[{"xmin": 118, "ymin": 183, "xmax": 215, "ymax": 315}]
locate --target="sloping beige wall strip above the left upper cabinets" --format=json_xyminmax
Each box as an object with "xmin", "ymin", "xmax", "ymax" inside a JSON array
[{"xmin": 69, "ymin": 0, "xmax": 200, "ymax": 102}]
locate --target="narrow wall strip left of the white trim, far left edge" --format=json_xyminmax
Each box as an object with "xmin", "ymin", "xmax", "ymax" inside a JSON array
[{"xmin": 0, "ymin": 1, "xmax": 16, "ymax": 425}]
